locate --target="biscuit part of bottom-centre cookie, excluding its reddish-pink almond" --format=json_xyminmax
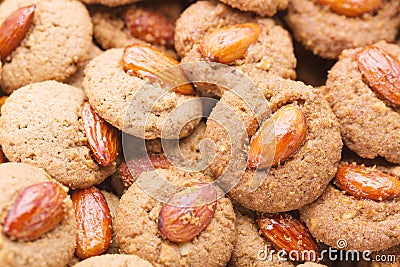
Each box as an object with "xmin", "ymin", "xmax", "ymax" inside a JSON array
[{"xmin": 115, "ymin": 168, "xmax": 236, "ymax": 267}]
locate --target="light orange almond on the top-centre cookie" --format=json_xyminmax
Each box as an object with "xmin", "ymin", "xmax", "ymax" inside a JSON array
[{"xmin": 200, "ymin": 23, "xmax": 261, "ymax": 64}]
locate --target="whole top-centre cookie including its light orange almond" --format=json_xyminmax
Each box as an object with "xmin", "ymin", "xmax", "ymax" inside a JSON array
[{"xmin": 175, "ymin": 1, "xmax": 296, "ymax": 89}]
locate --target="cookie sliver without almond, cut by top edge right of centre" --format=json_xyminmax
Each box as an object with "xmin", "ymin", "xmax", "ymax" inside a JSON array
[{"xmin": 221, "ymin": 0, "xmax": 288, "ymax": 17}]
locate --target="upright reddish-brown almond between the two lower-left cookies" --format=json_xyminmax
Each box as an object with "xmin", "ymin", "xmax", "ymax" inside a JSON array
[{"xmin": 71, "ymin": 187, "xmax": 112, "ymax": 259}]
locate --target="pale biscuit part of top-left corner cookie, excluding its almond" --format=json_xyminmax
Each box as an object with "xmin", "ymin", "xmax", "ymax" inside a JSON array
[{"xmin": 0, "ymin": 0, "xmax": 93, "ymax": 94}]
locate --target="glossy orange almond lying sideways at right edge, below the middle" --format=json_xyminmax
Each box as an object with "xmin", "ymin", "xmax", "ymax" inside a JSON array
[{"xmin": 334, "ymin": 164, "xmax": 400, "ymax": 201}]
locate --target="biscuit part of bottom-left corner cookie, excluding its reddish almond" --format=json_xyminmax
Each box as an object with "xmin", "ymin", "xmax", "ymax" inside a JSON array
[{"xmin": 0, "ymin": 163, "xmax": 76, "ymax": 267}]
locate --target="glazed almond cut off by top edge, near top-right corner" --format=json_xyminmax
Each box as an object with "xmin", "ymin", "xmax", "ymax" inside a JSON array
[{"xmin": 318, "ymin": 0, "xmax": 383, "ymax": 17}]
